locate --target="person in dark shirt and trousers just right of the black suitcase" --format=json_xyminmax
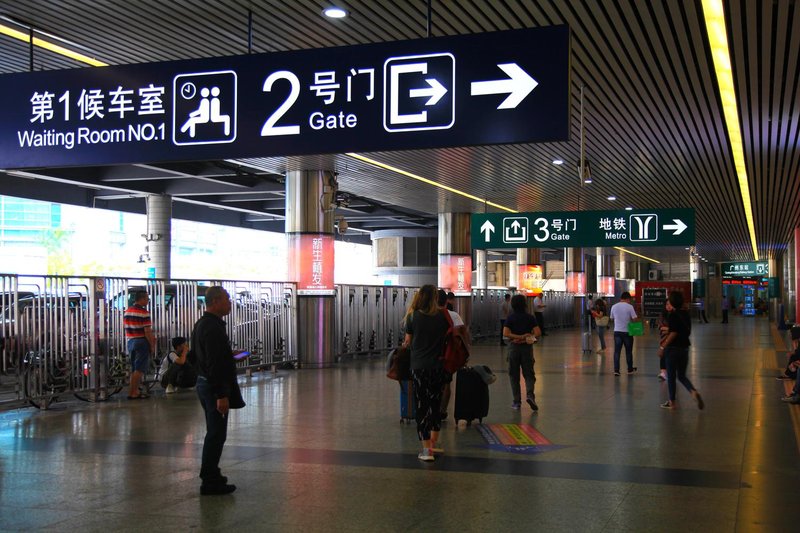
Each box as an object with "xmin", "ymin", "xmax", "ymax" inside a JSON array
[{"xmin": 503, "ymin": 294, "xmax": 542, "ymax": 413}]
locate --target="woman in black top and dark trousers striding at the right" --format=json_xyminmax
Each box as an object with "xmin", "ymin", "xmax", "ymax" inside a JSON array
[{"xmin": 659, "ymin": 291, "xmax": 705, "ymax": 409}]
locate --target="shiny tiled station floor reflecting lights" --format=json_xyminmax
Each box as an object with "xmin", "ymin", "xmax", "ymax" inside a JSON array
[{"xmin": 0, "ymin": 317, "xmax": 800, "ymax": 532}]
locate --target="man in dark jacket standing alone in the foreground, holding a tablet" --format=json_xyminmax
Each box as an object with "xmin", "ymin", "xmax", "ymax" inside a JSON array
[{"xmin": 192, "ymin": 286, "xmax": 244, "ymax": 495}]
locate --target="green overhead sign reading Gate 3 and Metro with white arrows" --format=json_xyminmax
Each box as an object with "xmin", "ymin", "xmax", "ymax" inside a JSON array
[{"xmin": 471, "ymin": 209, "xmax": 695, "ymax": 249}]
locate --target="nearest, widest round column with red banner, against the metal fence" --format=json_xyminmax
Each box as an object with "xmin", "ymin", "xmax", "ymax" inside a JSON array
[{"xmin": 286, "ymin": 170, "xmax": 336, "ymax": 368}]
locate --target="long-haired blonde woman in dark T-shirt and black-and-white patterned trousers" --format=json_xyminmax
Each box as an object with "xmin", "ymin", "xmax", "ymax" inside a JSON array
[{"xmin": 403, "ymin": 285, "xmax": 450, "ymax": 461}]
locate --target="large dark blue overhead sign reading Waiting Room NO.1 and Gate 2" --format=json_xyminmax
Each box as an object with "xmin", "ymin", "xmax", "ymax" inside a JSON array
[{"xmin": 0, "ymin": 26, "xmax": 570, "ymax": 169}]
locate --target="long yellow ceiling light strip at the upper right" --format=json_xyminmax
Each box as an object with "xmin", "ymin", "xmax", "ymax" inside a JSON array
[{"xmin": 703, "ymin": 0, "xmax": 758, "ymax": 261}]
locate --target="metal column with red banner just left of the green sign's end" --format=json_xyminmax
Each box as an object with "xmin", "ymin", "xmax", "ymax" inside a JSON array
[{"xmin": 439, "ymin": 213, "xmax": 472, "ymax": 324}]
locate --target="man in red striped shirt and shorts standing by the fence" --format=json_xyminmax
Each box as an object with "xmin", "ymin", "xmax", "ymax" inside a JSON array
[{"xmin": 123, "ymin": 291, "xmax": 156, "ymax": 400}]
